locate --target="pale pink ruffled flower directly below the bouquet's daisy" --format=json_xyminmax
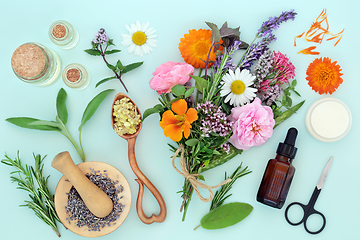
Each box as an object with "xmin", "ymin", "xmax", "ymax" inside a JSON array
[{"xmin": 229, "ymin": 98, "xmax": 275, "ymax": 150}]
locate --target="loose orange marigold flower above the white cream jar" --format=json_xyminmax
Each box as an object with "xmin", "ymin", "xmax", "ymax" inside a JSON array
[{"xmin": 306, "ymin": 57, "xmax": 343, "ymax": 94}]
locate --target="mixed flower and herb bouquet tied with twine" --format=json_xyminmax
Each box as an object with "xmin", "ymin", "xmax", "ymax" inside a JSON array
[{"xmin": 143, "ymin": 10, "xmax": 304, "ymax": 220}]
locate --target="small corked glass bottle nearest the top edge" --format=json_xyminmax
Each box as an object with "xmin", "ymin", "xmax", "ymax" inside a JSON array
[{"xmin": 49, "ymin": 20, "xmax": 79, "ymax": 49}]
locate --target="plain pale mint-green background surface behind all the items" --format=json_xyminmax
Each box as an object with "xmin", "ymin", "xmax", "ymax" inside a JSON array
[{"xmin": 0, "ymin": 0, "xmax": 360, "ymax": 240}]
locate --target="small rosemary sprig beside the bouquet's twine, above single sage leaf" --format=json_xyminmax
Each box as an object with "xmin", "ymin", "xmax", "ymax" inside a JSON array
[{"xmin": 209, "ymin": 163, "xmax": 251, "ymax": 211}]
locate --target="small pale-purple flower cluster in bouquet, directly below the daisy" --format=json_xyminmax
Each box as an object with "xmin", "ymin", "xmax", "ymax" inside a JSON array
[{"xmin": 196, "ymin": 101, "xmax": 232, "ymax": 138}]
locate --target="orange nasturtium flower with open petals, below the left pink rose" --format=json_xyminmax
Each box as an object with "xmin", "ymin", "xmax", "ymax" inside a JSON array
[{"xmin": 159, "ymin": 99, "xmax": 198, "ymax": 142}]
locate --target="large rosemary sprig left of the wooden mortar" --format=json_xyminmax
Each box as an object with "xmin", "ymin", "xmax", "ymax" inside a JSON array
[{"xmin": 1, "ymin": 152, "xmax": 61, "ymax": 237}]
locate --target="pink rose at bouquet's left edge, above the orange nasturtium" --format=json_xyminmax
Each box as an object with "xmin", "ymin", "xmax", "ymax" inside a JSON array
[{"xmin": 150, "ymin": 61, "xmax": 194, "ymax": 94}]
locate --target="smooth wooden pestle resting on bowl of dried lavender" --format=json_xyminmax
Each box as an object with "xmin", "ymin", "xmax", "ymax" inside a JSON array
[{"xmin": 51, "ymin": 151, "xmax": 113, "ymax": 218}]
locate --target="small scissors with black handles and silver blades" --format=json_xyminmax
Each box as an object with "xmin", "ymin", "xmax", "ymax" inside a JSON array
[{"xmin": 285, "ymin": 157, "xmax": 333, "ymax": 234}]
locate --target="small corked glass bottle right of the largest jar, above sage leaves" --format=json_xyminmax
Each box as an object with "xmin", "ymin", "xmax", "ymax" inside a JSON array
[{"xmin": 62, "ymin": 63, "xmax": 90, "ymax": 89}]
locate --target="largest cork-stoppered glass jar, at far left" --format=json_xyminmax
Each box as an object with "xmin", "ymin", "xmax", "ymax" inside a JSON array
[{"xmin": 11, "ymin": 42, "xmax": 61, "ymax": 85}]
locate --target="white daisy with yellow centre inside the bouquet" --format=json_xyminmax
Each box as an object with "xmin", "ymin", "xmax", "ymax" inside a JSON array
[{"xmin": 220, "ymin": 68, "xmax": 257, "ymax": 106}]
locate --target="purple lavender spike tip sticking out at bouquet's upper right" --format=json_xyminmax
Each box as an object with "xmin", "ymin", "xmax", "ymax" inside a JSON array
[{"xmin": 257, "ymin": 9, "xmax": 297, "ymax": 37}]
